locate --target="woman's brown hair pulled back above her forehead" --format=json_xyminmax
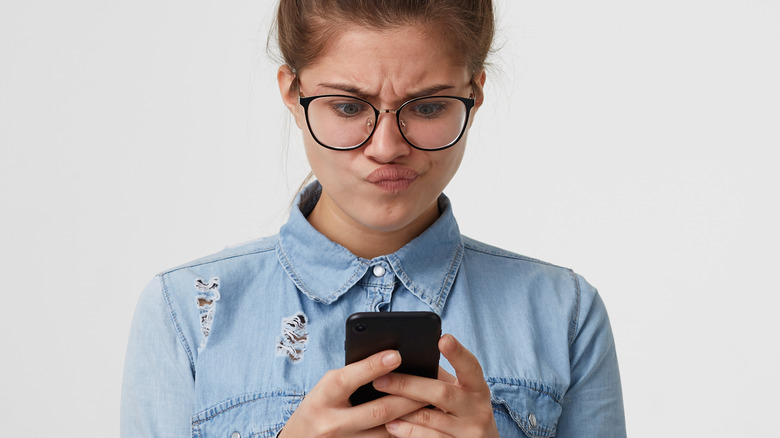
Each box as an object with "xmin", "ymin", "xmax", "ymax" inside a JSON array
[{"xmin": 275, "ymin": 0, "xmax": 494, "ymax": 87}]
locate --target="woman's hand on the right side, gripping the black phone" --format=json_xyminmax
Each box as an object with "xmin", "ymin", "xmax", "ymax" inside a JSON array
[{"xmin": 374, "ymin": 335, "xmax": 498, "ymax": 438}]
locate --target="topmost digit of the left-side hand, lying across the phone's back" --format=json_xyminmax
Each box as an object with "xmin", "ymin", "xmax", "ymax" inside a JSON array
[{"xmin": 322, "ymin": 350, "xmax": 401, "ymax": 401}]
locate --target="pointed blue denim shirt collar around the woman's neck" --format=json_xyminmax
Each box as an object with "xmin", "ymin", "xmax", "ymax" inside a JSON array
[{"xmin": 276, "ymin": 181, "xmax": 463, "ymax": 314}]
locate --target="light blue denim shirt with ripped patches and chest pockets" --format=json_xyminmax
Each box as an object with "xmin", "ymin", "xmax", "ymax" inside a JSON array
[{"xmin": 121, "ymin": 183, "xmax": 625, "ymax": 438}]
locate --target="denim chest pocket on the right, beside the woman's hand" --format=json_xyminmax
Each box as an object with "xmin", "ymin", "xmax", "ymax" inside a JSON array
[{"xmin": 488, "ymin": 379, "xmax": 561, "ymax": 438}]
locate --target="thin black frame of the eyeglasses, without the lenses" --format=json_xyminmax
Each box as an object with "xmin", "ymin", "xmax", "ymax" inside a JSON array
[{"xmin": 298, "ymin": 93, "xmax": 474, "ymax": 151}]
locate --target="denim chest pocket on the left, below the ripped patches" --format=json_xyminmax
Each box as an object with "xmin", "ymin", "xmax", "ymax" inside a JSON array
[{"xmin": 192, "ymin": 391, "xmax": 303, "ymax": 438}]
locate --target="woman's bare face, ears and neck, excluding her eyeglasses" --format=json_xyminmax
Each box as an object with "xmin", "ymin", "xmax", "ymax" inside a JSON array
[{"xmin": 279, "ymin": 26, "xmax": 484, "ymax": 241}]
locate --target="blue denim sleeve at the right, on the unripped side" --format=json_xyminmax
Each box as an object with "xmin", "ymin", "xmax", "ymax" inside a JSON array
[{"xmin": 557, "ymin": 276, "xmax": 626, "ymax": 438}]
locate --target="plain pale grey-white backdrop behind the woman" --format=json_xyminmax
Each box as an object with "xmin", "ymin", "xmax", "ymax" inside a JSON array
[{"xmin": 0, "ymin": 0, "xmax": 780, "ymax": 437}]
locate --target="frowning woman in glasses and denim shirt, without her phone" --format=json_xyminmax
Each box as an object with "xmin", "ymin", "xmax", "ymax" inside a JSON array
[{"xmin": 122, "ymin": 0, "xmax": 625, "ymax": 438}]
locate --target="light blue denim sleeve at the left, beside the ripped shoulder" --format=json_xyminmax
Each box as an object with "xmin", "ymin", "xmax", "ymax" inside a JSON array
[{"xmin": 120, "ymin": 277, "xmax": 195, "ymax": 438}]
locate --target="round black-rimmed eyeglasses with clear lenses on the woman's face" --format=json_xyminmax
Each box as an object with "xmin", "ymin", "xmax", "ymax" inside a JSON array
[{"xmin": 298, "ymin": 93, "xmax": 474, "ymax": 151}]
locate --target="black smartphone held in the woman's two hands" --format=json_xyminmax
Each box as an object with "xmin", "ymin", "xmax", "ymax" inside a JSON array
[{"xmin": 344, "ymin": 312, "xmax": 441, "ymax": 406}]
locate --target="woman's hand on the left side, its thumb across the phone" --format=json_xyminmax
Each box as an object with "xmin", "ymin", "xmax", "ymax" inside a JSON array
[{"xmin": 279, "ymin": 351, "xmax": 425, "ymax": 438}]
